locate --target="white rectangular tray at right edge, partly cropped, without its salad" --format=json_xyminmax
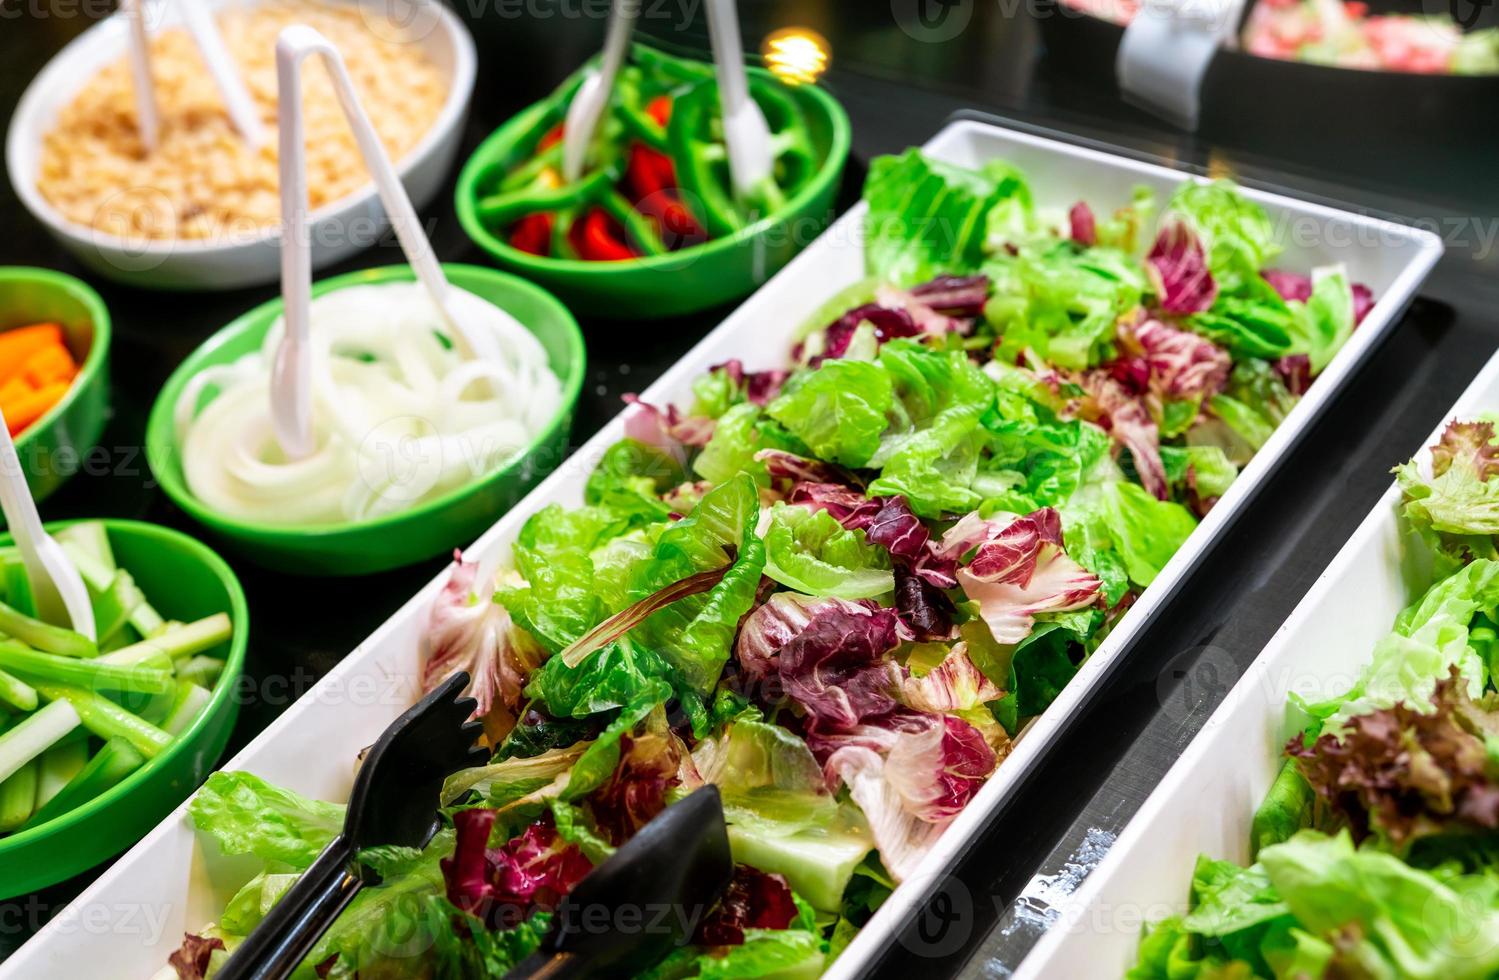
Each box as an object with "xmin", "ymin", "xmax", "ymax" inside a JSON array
[{"xmin": 1013, "ymin": 354, "xmax": 1499, "ymax": 980}]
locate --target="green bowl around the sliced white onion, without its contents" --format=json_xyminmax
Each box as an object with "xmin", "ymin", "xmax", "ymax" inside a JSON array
[{"xmin": 145, "ymin": 265, "xmax": 585, "ymax": 575}]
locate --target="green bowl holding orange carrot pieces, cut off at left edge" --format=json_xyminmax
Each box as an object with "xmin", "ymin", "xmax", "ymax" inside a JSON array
[{"xmin": 0, "ymin": 267, "xmax": 109, "ymax": 506}]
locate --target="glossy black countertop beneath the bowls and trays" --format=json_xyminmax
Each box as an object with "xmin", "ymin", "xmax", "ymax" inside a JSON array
[{"xmin": 0, "ymin": 0, "xmax": 1499, "ymax": 976}]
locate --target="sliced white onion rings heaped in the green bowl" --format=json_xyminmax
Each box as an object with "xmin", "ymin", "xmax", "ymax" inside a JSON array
[{"xmin": 172, "ymin": 283, "xmax": 562, "ymax": 526}]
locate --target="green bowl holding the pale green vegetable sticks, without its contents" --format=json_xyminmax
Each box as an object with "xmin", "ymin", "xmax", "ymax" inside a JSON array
[{"xmin": 0, "ymin": 518, "xmax": 250, "ymax": 899}]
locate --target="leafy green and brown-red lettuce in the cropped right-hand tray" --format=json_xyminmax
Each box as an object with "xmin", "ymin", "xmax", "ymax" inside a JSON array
[{"xmin": 1127, "ymin": 420, "xmax": 1499, "ymax": 980}]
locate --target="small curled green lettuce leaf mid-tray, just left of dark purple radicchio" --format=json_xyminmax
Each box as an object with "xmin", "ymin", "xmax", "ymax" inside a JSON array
[{"xmin": 764, "ymin": 500, "xmax": 895, "ymax": 599}]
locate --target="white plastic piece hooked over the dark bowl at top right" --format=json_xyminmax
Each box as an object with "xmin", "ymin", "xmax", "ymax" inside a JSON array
[{"xmin": 1114, "ymin": 0, "xmax": 1244, "ymax": 130}]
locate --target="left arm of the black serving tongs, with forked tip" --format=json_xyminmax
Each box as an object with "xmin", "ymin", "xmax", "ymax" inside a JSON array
[{"xmin": 214, "ymin": 673, "xmax": 486, "ymax": 980}]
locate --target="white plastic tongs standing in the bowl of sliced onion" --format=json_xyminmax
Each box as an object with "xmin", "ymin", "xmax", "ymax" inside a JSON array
[{"xmin": 271, "ymin": 24, "xmax": 525, "ymax": 460}]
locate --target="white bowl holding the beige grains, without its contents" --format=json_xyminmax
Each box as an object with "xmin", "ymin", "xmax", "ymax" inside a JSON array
[{"xmin": 4, "ymin": 0, "xmax": 475, "ymax": 289}]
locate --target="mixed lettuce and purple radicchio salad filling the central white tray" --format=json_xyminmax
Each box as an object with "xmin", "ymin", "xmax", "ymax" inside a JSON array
[{"xmin": 164, "ymin": 150, "xmax": 1370, "ymax": 979}]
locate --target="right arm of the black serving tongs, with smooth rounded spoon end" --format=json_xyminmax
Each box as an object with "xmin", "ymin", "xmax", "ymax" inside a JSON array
[{"xmin": 505, "ymin": 785, "xmax": 735, "ymax": 980}]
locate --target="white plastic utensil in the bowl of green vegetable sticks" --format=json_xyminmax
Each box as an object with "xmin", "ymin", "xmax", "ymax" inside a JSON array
[{"xmin": 0, "ymin": 414, "xmax": 96, "ymax": 640}]
